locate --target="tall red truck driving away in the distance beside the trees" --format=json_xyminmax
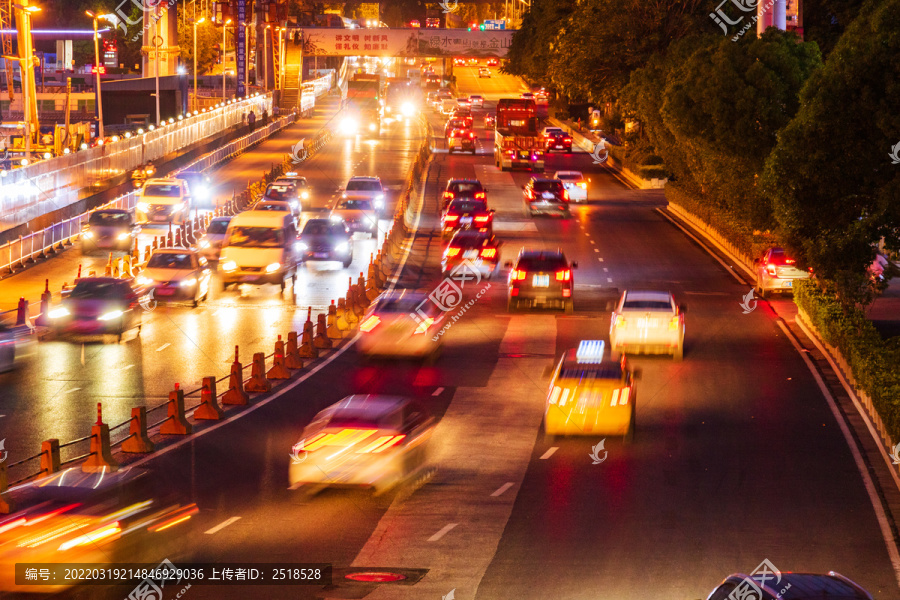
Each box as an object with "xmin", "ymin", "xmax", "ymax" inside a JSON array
[{"xmin": 494, "ymin": 98, "xmax": 544, "ymax": 172}]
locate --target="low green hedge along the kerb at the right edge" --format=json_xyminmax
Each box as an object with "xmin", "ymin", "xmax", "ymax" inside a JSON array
[{"xmin": 794, "ymin": 280, "xmax": 900, "ymax": 440}]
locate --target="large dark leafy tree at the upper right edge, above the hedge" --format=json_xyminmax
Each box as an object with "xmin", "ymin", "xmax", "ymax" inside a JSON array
[{"xmin": 762, "ymin": 0, "xmax": 900, "ymax": 309}]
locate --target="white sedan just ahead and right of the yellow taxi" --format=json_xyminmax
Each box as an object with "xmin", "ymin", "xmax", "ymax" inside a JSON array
[{"xmin": 609, "ymin": 290, "xmax": 686, "ymax": 360}]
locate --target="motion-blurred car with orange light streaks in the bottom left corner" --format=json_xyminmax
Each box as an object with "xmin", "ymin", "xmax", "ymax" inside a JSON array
[{"xmin": 0, "ymin": 467, "xmax": 198, "ymax": 594}]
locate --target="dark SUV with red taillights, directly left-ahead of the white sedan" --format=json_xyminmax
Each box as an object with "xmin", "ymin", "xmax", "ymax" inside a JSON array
[{"xmin": 507, "ymin": 248, "xmax": 578, "ymax": 313}]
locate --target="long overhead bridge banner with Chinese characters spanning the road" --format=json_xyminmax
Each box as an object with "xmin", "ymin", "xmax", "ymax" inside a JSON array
[{"xmin": 296, "ymin": 28, "xmax": 515, "ymax": 58}]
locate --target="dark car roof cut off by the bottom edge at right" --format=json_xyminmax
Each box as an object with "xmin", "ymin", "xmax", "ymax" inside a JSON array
[{"xmin": 706, "ymin": 570, "xmax": 874, "ymax": 600}]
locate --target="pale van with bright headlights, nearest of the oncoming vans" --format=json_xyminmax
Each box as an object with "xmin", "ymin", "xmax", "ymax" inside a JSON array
[{"xmin": 218, "ymin": 210, "xmax": 300, "ymax": 290}]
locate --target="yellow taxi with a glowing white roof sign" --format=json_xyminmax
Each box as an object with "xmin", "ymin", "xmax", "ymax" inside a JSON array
[{"xmin": 541, "ymin": 340, "xmax": 640, "ymax": 441}]
